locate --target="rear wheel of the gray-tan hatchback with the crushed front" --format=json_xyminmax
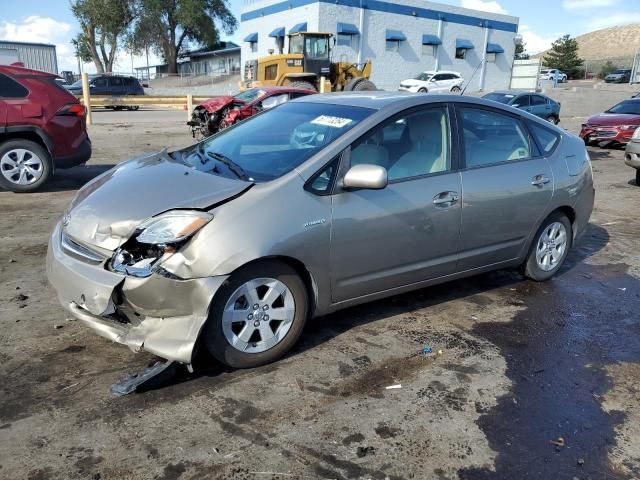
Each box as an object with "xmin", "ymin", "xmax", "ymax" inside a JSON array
[{"xmin": 524, "ymin": 212, "xmax": 573, "ymax": 282}]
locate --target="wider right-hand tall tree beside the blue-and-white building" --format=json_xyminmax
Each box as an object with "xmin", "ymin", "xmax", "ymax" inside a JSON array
[{"xmin": 134, "ymin": 0, "xmax": 238, "ymax": 73}]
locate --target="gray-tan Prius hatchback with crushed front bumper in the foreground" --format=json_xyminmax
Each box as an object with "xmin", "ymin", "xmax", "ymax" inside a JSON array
[{"xmin": 47, "ymin": 92, "xmax": 594, "ymax": 367}]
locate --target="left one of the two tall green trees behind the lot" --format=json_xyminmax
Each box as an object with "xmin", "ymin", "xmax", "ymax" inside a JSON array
[{"xmin": 71, "ymin": 0, "xmax": 133, "ymax": 73}]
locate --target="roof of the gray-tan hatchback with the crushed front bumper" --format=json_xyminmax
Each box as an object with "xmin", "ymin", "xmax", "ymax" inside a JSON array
[{"xmin": 293, "ymin": 91, "xmax": 510, "ymax": 110}]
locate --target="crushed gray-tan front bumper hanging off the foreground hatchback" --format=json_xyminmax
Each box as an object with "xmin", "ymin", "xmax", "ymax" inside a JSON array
[{"xmin": 47, "ymin": 224, "xmax": 228, "ymax": 364}]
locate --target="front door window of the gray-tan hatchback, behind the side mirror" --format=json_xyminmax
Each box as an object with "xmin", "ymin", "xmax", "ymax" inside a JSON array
[{"xmin": 351, "ymin": 107, "xmax": 451, "ymax": 181}]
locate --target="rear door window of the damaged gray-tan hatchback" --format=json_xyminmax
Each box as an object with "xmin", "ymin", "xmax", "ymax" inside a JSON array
[{"xmin": 461, "ymin": 107, "xmax": 531, "ymax": 167}]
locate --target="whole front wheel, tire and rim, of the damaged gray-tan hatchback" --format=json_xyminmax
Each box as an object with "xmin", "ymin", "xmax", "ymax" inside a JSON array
[{"xmin": 203, "ymin": 261, "xmax": 309, "ymax": 368}]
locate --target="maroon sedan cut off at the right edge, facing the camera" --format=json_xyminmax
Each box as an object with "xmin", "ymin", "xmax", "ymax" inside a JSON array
[{"xmin": 580, "ymin": 98, "xmax": 640, "ymax": 145}]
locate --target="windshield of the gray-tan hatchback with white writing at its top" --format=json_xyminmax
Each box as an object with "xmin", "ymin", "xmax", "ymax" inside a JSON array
[{"xmin": 182, "ymin": 102, "xmax": 374, "ymax": 182}]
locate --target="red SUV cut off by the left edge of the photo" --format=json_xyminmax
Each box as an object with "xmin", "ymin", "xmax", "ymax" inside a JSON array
[{"xmin": 0, "ymin": 65, "xmax": 91, "ymax": 192}]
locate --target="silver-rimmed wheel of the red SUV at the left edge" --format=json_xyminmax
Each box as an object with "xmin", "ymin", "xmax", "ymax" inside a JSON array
[{"xmin": 0, "ymin": 139, "xmax": 53, "ymax": 193}]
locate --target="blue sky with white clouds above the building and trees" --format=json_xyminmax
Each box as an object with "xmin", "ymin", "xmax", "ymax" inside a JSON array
[{"xmin": 0, "ymin": 0, "xmax": 640, "ymax": 72}]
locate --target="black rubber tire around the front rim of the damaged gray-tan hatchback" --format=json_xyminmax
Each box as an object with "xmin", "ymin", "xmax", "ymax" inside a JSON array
[{"xmin": 202, "ymin": 260, "xmax": 309, "ymax": 368}]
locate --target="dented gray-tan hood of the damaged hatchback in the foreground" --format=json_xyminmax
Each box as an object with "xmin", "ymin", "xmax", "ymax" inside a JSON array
[{"xmin": 63, "ymin": 152, "xmax": 251, "ymax": 250}]
